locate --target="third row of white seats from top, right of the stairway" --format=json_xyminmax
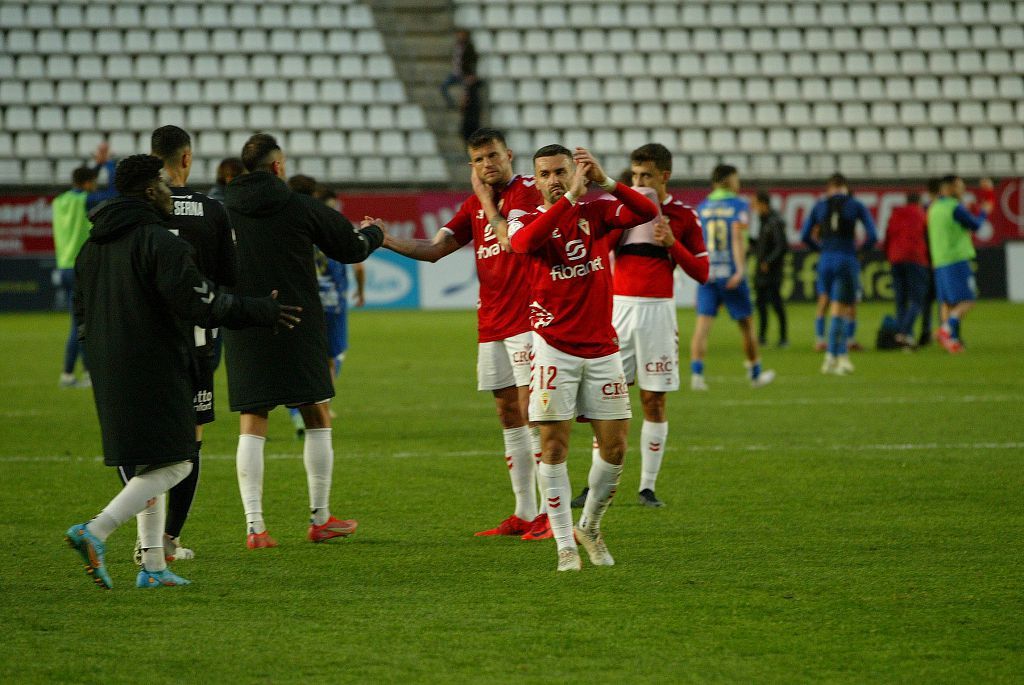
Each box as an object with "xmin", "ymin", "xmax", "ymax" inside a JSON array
[{"xmin": 480, "ymin": 48, "xmax": 1024, "ymax": 78}]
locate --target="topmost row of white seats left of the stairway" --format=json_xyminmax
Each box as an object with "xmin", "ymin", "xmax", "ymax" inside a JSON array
[{"xmin": 0, "ymin": 2, "xmax": 374, "ymax": 31}]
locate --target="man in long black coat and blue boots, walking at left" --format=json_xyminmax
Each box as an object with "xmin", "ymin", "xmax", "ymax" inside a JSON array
[{"xmin": 67, "ymin": 155, "xmax": 298, "ymax": 588}]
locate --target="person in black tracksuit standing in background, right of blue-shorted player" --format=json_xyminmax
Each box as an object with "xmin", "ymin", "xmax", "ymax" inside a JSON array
[{"xmin": 753, "ymin": 191, "xmax": 790, "ymax": 347}]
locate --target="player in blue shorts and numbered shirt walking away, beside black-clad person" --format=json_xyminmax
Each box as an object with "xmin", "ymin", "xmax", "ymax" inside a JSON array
[{"xmin": 690, "ymin": 164, "xmax": 775, "ymax": 390}]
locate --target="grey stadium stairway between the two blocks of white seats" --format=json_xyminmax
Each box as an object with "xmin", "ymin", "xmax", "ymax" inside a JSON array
[{"xmin": 368, "ymin": 0, "xmax": 469, "ymax": 185}]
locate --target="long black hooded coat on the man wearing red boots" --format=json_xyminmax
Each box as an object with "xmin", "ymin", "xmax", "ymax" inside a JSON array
[{"xmin": 224, "ymin": 171, "xmax": 384, "ymax": 412}]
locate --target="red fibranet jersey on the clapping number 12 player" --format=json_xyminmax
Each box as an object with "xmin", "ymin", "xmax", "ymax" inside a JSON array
[{"xmin": 509, "ymin": 183, "xmax": 657, "ymax": 359}]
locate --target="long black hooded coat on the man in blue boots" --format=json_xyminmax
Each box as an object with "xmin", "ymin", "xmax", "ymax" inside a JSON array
[{"xmin": 75, "ymin": 198, "xmax": 284, "ymax": 466}]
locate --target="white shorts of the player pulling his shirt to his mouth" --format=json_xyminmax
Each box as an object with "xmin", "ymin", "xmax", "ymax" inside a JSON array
[{"xmin": 611, "ymin": 295, "xmax": 679, "ymax": 392}]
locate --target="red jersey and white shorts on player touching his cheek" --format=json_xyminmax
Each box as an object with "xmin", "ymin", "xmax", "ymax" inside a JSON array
[{"xmin": 441, "ymin": 176, "xmax": 542, "ymax": 390}]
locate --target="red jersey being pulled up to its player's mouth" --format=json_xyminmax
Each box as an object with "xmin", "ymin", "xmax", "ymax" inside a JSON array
[{"xmin": 613, "ymin": 196, "xmax": 709, "ymax": 298}]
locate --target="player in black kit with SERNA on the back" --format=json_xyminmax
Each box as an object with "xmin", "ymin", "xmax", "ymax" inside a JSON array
[{"xmin": 118, "ymin": 126, "xmax": 236, "ymax": 563}]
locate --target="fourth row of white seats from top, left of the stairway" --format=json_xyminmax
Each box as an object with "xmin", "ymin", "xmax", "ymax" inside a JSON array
[{"xmin": 0, "ymin": 79, "xmax": 408, "ymax": 104}]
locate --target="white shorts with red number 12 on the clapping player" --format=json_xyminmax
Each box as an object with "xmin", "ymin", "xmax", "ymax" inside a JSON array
[{"xmin": 529, "ymin": 333, "xmax": 633, "ymax": 421}]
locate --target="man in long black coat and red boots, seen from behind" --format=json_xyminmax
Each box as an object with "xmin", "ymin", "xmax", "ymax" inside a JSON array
[{"xmin": 224, "ymin": 133, "xmax": 384, "ymax": 549}]
